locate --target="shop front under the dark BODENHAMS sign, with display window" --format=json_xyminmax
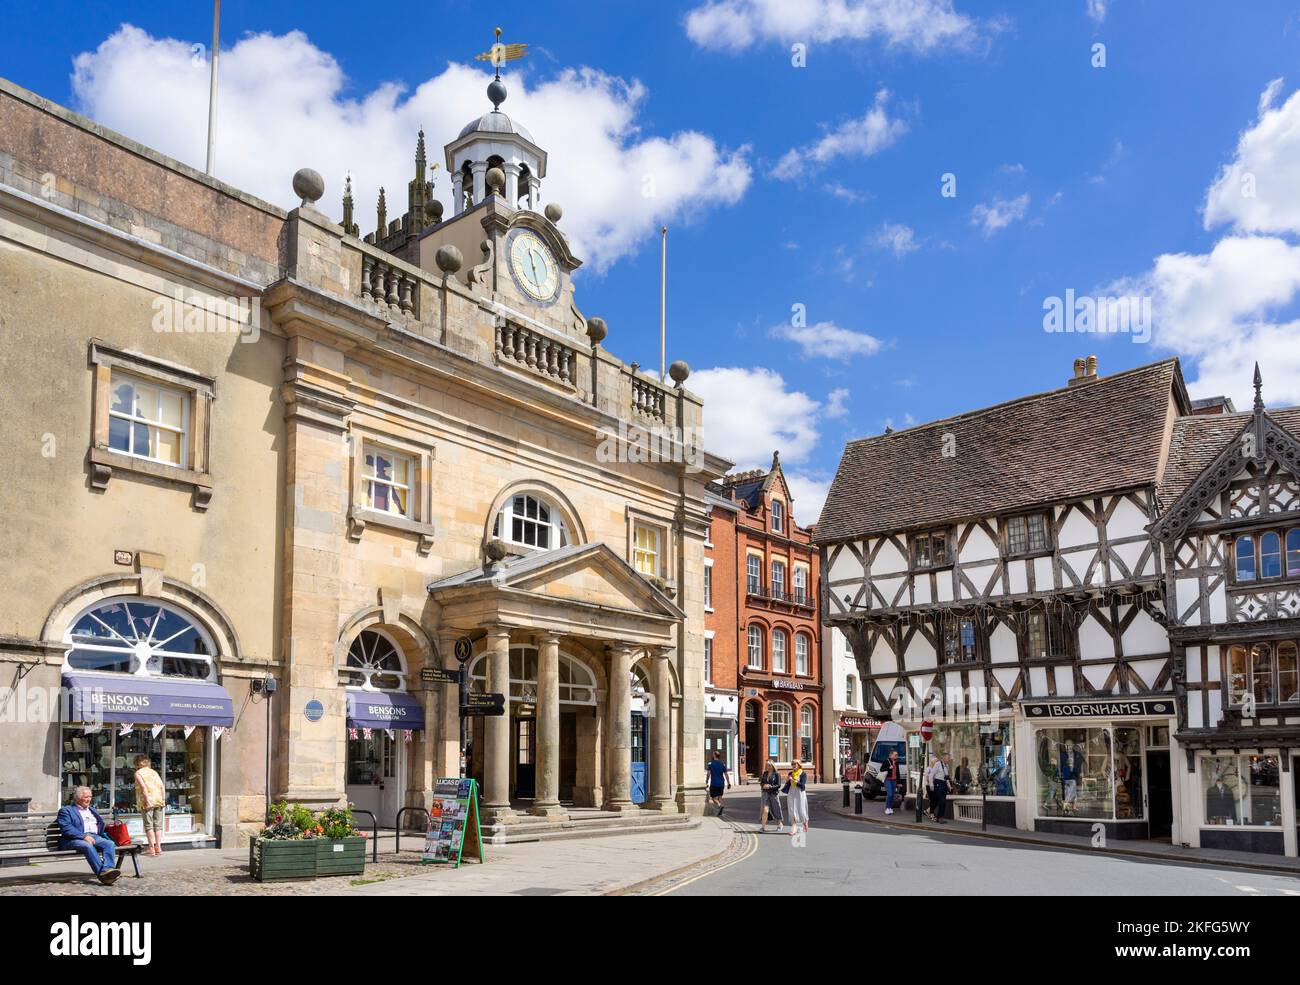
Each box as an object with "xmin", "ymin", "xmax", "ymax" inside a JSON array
[{"xmin": 1019, "ymin": 698, "xmax": 1177, "ymax": 839}]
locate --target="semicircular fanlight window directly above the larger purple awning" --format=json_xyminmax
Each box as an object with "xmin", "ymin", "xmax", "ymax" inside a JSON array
[{"xmin": 64, "ymin": 596, "xmax": 217, "ymax": 681}]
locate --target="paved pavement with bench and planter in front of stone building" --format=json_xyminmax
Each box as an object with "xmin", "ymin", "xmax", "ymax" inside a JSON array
[{"xmin": 0, "ymin": 819, "xmax": 744, "ymax": 897}]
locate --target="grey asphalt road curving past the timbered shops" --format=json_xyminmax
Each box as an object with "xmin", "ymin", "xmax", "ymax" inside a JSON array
[{"xmin": 671, "ymin": 789, "xmax": 1300, "ymax": 897}]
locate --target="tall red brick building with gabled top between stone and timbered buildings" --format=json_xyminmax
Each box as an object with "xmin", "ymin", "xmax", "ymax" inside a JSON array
[{"xmin": 705, "ymin": 455, "xmax": 822, "ymax": 776}]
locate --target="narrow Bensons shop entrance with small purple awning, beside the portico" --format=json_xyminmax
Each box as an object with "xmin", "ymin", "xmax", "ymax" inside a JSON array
[{"xmin": 345, "ymin": 687, "xmax": 425, "ymax": 828}]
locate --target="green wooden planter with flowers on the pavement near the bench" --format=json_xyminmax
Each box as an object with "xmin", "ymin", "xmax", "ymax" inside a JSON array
[{"xmin": 248, "ymin": 803, "xmax": 365, "ymax": 882}]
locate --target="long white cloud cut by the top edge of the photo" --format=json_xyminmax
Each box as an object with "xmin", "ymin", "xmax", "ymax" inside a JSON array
[{"xmin": 686, "ymin": 0, "xmax": 996, "ymax": 52}]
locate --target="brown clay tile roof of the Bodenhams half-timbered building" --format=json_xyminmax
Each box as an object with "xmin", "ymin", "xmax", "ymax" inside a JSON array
[{"xmin": 815, "ymin": 359, "xmax": 1185, "ymax": 543}]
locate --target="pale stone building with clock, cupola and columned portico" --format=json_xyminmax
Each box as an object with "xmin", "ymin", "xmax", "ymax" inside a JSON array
[{"xmin": 0, "ymin": 73, "xmax": 727, "ymax": 845}]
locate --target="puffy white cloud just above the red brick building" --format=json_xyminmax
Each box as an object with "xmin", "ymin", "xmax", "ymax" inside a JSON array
[{"xmin": 690, "ymin": 366, "xmax": 820, "ymax": 468}]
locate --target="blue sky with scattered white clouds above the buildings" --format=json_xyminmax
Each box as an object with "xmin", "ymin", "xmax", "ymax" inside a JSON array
[{"xmin": 0, "ymin": 0, "xmax": 1300, "ymax": 524}]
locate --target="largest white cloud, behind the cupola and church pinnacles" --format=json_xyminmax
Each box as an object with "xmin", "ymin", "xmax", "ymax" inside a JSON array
[{"xmin": 73, "ymin": 26, "xmax": 751, "ymax": 272}]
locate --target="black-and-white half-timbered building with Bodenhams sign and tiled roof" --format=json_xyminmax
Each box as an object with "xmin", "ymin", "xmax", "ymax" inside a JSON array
[{"xmin": 816, "ymin": 357, "xmax": 1242, "ymax": 841}]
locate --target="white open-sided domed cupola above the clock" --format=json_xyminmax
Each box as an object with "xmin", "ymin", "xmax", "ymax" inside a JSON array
[{"xmin": 445, "ymin": 45, "xmax": 546, "ymax": 216}]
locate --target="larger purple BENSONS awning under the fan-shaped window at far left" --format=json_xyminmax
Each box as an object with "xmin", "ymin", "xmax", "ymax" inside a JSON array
[{"xmin": 64, "ymin": 673, "xmax": 235, "ymax": 728}]
